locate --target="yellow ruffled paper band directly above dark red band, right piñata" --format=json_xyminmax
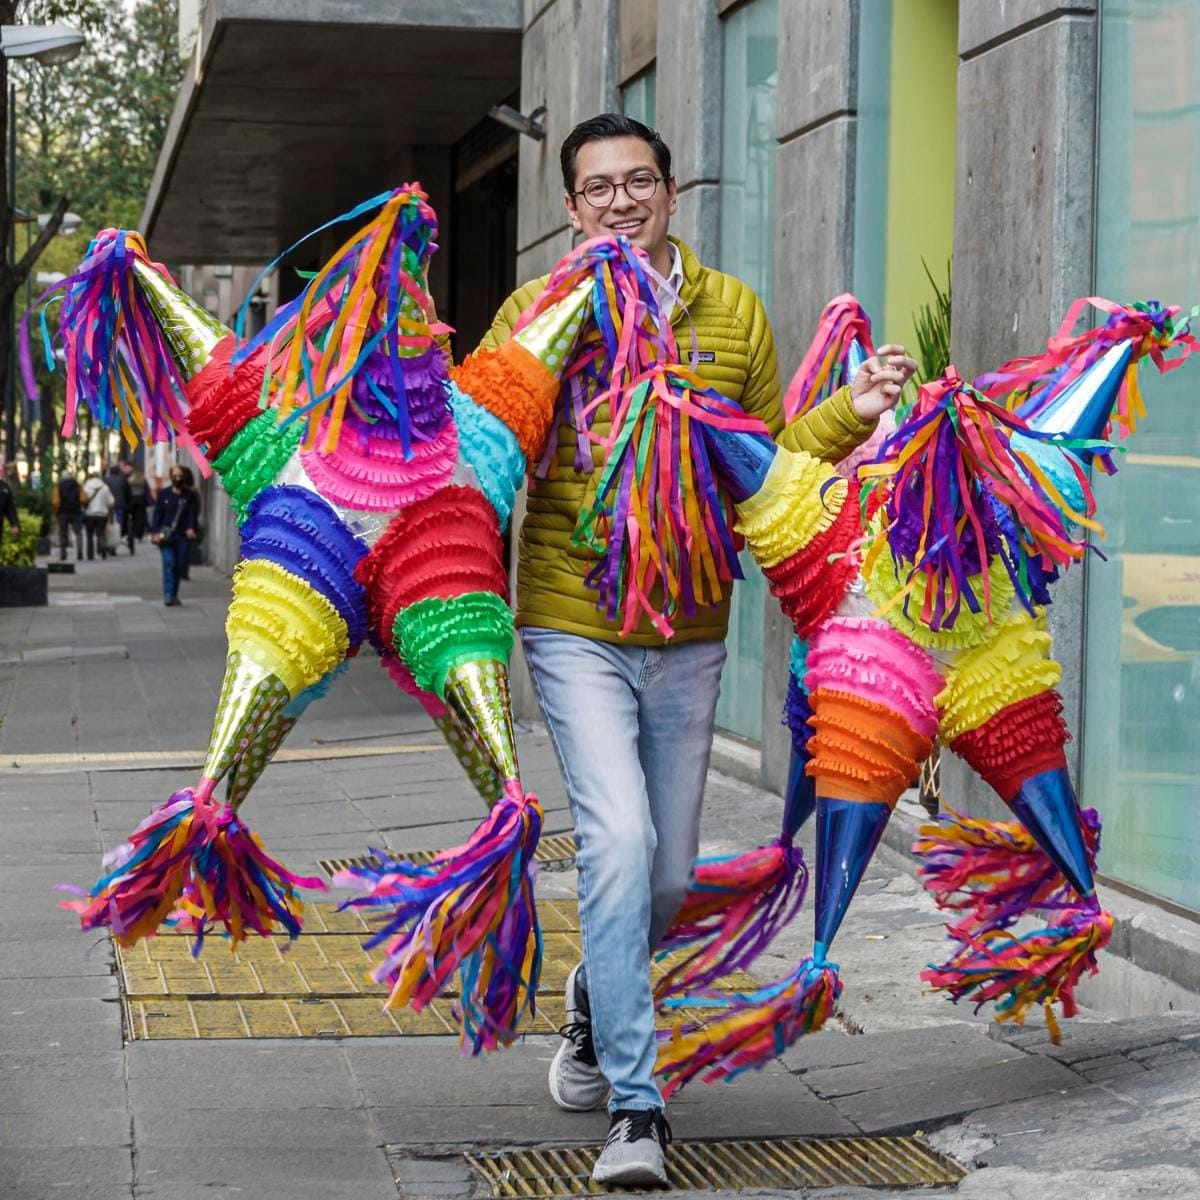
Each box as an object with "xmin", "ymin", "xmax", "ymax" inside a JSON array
[{"xmin": 937, "ymin": 610, "xmax": 1062, "ymax": 743}]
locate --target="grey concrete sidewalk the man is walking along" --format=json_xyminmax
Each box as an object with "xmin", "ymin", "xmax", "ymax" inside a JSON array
[{"xmin": 0, "ymin": 547, "xmax": 1200, "ymax": 1200}]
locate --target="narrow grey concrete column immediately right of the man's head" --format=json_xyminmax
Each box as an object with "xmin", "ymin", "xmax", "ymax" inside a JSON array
[{"xmin": 655, "ymin": 0, "xmax": 721, "ymax": 263}]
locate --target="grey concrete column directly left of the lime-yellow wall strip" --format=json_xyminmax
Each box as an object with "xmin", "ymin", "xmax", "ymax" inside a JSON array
[{"xmin": 758, "ymin": 0, "xmax": 859, "ymax": 792}]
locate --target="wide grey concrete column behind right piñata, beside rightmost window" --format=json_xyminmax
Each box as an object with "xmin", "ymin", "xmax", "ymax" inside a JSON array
[{"xmin": 942, "ymin": 0, "xmax": 1098, "ymax": 816}]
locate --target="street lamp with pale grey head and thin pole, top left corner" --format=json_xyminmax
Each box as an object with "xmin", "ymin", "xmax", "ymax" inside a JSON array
[{"xmin": 0, "ymin": 25, "xmax": 84, "ymax": 475}]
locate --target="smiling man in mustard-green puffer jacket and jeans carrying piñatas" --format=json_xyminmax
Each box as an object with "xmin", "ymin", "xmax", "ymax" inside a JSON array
[{"xmin": 472, "ymin": 113, "xmax": 916, "ymax": 1184}]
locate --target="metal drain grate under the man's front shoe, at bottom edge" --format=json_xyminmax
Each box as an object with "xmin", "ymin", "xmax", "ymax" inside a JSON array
[{"xmin": 463, "ymin": 1138, "xmax": 967, "ymax": 1200}]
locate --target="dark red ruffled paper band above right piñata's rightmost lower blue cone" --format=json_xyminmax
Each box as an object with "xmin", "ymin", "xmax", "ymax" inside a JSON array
[{"xmin": 950, "ymin": 689, "xmax": 1070, "ymax": 802}]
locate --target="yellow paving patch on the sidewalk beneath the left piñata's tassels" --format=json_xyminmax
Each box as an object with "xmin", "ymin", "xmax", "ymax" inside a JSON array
[{"xmin": 116, "ymin": 899, "xmax": 754, "ymax": 1042}]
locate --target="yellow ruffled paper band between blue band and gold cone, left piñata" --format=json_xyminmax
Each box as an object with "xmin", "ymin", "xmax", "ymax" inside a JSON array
[{"xmin": 226, "ymin": 558, "xmax": 349, "ymax": 698}]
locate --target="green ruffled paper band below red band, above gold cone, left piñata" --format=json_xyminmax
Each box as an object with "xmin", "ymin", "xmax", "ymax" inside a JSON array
[{"xmin": 392, "ymin": 592, "xmax": 512, "ymax": 700}]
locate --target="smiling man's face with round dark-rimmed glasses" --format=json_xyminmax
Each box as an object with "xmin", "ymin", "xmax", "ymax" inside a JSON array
[{"xmin": 563, "ymin": 137, "xmax": 676, "ymax": 262}]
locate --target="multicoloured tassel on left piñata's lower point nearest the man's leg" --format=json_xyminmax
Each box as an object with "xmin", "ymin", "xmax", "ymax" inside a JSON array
[{"xmin": 334, "ymin": 785, "xmax": 542, "ymax": 1054}]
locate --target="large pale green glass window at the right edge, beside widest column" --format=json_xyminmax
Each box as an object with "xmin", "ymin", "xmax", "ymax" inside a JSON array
[{"xmin": 1081, "ymin": 0, "xmax": 1200, "ymax": 908}]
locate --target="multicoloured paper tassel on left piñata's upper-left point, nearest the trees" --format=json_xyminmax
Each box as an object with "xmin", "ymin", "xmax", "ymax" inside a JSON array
[{"xmin": 26, "ymin": 229, "xmax": 209, "ymax": 465}]
